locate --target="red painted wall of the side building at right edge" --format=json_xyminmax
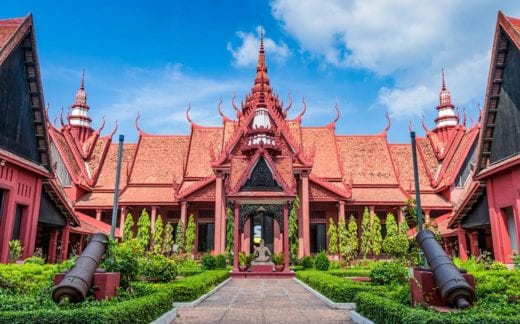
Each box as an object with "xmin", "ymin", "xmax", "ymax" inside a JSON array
[{"xmin": 486, "ymin": 167, "xmax": 520, "ymax": 263}]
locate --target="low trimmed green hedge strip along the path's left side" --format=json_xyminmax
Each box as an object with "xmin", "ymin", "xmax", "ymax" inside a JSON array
[{"xmin": 0, "ymin": 270, "xmax": 229, "ymax": 324}]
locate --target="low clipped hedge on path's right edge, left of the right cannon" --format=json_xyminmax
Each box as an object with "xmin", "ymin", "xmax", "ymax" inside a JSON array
[{"xmin": 296, "ymin": 270, "xmax": 378, "ymax": 303}]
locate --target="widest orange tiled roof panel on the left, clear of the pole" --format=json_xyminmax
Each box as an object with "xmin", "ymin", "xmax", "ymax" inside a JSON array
[{"xmin": 130, "ymin": 135, "xmax": 187, "ymax": 184}]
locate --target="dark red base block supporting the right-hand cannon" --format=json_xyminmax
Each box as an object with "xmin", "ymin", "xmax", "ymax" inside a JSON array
[{"xmin": 410, "ymin": 268, "xmax": 475, "ymax": 309}]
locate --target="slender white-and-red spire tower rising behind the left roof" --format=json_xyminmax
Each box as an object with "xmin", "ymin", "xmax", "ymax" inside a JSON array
[{"xmin": 67, "ymin": 70, "xmax": 93, "ymax": 142}]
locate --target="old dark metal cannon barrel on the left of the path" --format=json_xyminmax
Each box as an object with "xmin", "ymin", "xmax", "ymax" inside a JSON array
[{"xmin": 52, "ymin": 233, "xmax": 108, "ymax": 303}]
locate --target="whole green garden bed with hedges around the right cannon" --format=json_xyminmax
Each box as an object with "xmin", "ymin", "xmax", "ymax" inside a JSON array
[{"xmin": 296, "ymin": 270, "xmax": 520, "ymax": 324}]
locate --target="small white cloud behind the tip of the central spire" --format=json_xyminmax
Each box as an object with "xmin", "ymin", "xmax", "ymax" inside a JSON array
[{"xmin": 227, "ymin": 26, "xmax": 290, "ymax": 66}]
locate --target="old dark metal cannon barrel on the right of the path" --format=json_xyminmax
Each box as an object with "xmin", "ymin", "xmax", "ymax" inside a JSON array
[{"xmin": 417, "ymin": 230, "xmax": 475, "ymax": 308}]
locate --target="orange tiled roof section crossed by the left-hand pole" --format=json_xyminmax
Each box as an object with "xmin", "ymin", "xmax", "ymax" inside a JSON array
[{"xmin": 96, "ymin": 143, "xmax": 136, "ymax": 190}]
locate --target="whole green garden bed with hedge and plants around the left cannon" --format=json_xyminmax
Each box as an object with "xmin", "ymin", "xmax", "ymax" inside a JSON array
[{"xmin": 0, "ymin": 265, "xmax": 229, "ymax": 323}]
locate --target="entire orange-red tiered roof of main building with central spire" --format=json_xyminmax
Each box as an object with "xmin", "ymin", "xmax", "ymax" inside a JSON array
[{"xmin": 50, "ymin": 33, "xmax": 478, "ymax": 216}]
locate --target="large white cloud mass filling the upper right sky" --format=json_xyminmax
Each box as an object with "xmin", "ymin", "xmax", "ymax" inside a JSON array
[{"xmin": 271, "ymin": 0, "xmax": 520, "ymax": 117}]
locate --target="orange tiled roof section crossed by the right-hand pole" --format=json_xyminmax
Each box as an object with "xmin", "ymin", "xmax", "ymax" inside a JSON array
[{"xmin": 390, "ymin": 144, "xmax": 433, "ymax": 191}]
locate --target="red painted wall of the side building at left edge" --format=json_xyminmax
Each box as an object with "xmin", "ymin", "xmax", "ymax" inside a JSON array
[{"xmin": 0, "ymin": 162, "xmax": 42, "ymax": 263}]
